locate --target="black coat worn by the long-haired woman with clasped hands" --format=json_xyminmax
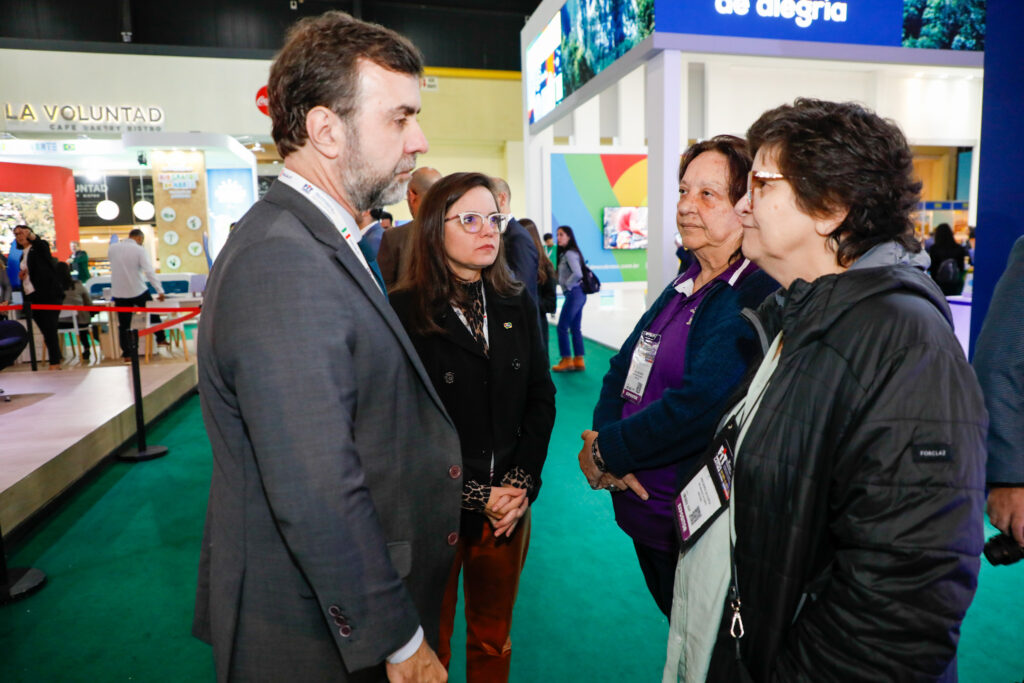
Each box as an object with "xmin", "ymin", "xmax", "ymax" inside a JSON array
[{"xmin": 391, "ymin": 288, "xmax": 555, "ymax": 533}]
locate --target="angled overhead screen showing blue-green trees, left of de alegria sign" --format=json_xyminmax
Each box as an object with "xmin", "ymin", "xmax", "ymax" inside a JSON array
[{"xmin": 525, "ymin": 0, "xmax": 654, "ymax": 123}]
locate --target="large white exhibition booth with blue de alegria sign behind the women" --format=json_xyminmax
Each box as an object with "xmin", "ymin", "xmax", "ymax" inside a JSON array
[{"xmin": 521, "ymin": 0, "xmax": 984, "ymax": 346}]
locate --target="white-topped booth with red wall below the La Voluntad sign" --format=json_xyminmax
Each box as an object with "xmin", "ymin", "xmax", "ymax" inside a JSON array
[{"xmin": 0, "ymin": 132, "xmax": 256, "ymax": 274}]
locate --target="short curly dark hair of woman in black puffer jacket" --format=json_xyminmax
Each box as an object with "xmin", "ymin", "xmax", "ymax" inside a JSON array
[{"xmin": 746, "ymin": 97, "xmax": 922, "ymax": 266}]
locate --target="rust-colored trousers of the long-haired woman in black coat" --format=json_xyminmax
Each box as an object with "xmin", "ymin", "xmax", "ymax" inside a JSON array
[{"xmin": 437, "ymin": 509, "xmax": 530, "ymax": 683}]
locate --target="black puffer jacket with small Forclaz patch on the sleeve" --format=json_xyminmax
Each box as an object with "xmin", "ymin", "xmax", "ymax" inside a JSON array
[{"xmin": 709, "ymin": 265, "xmax": 987, "ymax": 682}]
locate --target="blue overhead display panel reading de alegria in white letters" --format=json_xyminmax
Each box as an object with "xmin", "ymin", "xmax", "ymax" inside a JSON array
[{"xmin": 655, "ymin": 0, "xmax": 985, "ymax": 51}]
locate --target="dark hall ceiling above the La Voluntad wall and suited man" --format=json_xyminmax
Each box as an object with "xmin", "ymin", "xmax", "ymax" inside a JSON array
[{"xmin": 0, "ymin": 0, "xmax": 539, "ymax": 71}]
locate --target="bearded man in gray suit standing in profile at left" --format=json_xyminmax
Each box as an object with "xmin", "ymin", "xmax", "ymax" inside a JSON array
[{"xmin": 194, "ymin": 11, "xmax": 462, "ymax": 683}]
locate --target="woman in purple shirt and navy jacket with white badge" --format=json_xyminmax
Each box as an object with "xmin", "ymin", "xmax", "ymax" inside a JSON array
[{"xmin": 580, "ymin": 135, "xmax": 777, "ymax": 616}]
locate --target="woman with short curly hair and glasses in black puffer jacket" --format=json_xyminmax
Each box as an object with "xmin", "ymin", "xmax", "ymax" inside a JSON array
[{"xmin": 665, "ymin": 99, "xmax": 987, "ymax": 681}]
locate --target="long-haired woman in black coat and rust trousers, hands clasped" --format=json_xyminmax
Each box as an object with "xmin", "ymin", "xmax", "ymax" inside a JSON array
[{"xmin": 391, "ymin": 173, "xmax": 555, "ymax": 682}]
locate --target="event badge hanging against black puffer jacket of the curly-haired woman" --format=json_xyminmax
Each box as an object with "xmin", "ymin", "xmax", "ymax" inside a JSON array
[{"xmin": 673, "ymin": 419, "xmax": 738, "ymax": 550}]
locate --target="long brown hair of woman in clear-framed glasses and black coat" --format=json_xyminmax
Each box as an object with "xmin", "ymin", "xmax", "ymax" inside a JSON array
[{"xmin": 391, "ymin": 173, "xmax": 522, "ymax": 334}]
